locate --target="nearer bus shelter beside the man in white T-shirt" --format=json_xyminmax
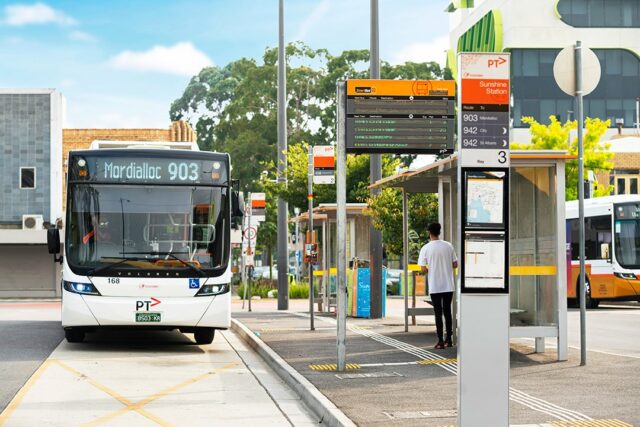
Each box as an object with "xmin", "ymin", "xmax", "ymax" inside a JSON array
[{"xmin": 371, "ymin": 150, "xmax": 574, "ymax": 360}]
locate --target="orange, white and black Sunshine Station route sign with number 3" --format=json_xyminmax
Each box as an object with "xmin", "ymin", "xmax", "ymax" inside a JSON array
[{"xmin": 459, "ymin": 53, "xmax": 510, "ymax": 167}]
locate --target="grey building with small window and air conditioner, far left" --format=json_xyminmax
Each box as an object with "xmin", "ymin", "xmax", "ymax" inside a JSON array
[{"xmin": 0, "ymin": 89, "xmax": 64, "ymax": 297}]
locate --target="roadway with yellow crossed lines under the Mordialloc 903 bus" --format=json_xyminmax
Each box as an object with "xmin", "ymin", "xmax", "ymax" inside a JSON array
[{"xmin": 0, "ymin": 302, "xmax": 318, "ymax": 427}]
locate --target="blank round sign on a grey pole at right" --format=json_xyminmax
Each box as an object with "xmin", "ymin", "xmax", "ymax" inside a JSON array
[{"xmin": 553, "ymin": 46, "xmax": 602, "ymax": 96}]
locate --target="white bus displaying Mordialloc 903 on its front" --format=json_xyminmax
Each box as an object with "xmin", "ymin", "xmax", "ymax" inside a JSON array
[{"xmin": 48, "ymin": 142, "xmax": 243, "ymax": 344}]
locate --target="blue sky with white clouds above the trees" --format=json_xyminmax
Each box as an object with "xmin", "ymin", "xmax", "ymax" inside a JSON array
[{"xmin": 0, "ymin": 0, "xmax": 448, "ymax": 128}]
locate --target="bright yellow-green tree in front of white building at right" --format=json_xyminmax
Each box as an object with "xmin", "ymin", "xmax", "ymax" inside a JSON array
[{"xmin": 511, "ymin": 116, "xmax": 613, "ymax": 200}]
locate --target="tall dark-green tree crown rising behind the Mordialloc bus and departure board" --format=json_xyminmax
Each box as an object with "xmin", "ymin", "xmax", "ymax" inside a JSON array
[{"xmin": 170, "ymin": 42, "xmax": 447, "ymax": 192}]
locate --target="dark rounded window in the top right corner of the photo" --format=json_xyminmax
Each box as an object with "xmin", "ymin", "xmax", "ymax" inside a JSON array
[{"xmin": 558, "ymin": 0, "xmax": 640, "ymax": 28}]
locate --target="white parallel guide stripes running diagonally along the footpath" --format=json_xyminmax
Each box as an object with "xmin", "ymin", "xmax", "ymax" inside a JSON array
[{"xmin": 300, "ymin": 313, "xmax": 592, "ymax": 421}]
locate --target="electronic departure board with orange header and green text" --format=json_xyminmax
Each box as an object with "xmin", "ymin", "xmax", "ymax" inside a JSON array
[{"xmin": 346, "ymin": 80, "xmax": 456, "ymax": 154}]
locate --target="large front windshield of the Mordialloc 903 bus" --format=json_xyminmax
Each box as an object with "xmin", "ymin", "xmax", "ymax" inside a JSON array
[{"xmin": 65, "ymin": 183, "xmax": 229, "ymax": 277}]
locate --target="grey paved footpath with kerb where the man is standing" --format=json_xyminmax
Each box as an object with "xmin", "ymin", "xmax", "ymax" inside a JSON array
[{"xmin": 233, "ymin": 300, "xmax": 640, "ymax": 427}]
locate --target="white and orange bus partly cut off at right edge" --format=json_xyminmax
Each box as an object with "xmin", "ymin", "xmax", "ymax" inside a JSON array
[{"xmin": 566, "ymin": 195, "xmax": 640, "ymax": 308}]
